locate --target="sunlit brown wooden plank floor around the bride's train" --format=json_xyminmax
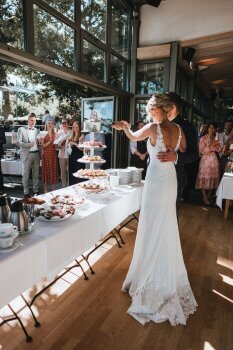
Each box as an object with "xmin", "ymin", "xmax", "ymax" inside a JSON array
[{"xmin": 0, "ymin": 204, "xmax": 233, "ymax": 350}]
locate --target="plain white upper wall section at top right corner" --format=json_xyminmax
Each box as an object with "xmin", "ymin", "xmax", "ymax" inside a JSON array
[{"xmin": 139, "ymin": 0, "xmax": 233, "ymax": 46}]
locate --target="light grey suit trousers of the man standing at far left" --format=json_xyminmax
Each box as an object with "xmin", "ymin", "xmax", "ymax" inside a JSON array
[{"xmin": 22, "ymin": 152, "xmax": 40, "ymax": 194}]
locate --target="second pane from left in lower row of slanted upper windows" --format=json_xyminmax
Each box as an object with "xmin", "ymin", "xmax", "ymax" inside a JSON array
[{"xmin": 34, "ymin": 5, "xmax": 74, "ymax": 67}]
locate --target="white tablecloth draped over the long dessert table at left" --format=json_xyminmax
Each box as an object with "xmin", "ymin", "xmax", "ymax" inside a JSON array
[{"xmin": 0, "ymin": 186, "xmax": 143, "ymax": 307}]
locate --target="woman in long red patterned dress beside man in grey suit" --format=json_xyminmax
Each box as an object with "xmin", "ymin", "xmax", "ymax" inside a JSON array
[{"xmin": 41, "ymin": 120, "xmax": 58, "ymax": 193}]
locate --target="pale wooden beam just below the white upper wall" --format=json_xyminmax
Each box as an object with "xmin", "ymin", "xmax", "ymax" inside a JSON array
[{"xmin": 137, "ymin": 44, "xmax": 171, "ymax": 60}]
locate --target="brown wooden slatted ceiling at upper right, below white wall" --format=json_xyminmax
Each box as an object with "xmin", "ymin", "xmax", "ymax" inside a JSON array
[{"xmin": 180, "ymin": 31, "xmax": 233, "ymax": 99}]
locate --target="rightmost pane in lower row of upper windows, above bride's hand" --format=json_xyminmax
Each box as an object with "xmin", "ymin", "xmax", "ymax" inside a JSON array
[{"xmin": 110, "ymin": 55, "xmax": 129, "ymax": 91}]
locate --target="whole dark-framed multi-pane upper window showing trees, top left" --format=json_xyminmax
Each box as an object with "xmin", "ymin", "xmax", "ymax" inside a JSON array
[{"xmin": 0, "ymin": 0, "xmax": 132, "ymax": 91}]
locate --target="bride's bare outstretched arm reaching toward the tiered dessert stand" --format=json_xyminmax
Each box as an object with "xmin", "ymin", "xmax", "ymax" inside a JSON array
[{"xmin": 112, "ymin": 120, "xmax": 151, "ymax": 141}]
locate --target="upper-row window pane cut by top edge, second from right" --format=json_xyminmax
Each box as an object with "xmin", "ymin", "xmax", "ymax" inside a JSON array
[{"xmin": 81, "ymin": 0, "xmax": 107, "ymax": 42}]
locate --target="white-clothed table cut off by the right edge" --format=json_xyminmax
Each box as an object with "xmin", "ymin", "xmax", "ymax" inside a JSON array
[{"xmin": 216, "ymin": 173, "xmax": 233, "ymax": 219}]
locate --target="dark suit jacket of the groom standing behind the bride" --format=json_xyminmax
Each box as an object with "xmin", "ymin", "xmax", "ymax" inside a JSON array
[{"xmin": 172, "ymin": 115, "xmax": 199, "ymax": 165}]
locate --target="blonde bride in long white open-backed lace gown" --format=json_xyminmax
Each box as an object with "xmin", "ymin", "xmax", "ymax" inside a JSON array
[{"xmin": 113, "ymin": 94, "xmax": 197, "ymax": 326}]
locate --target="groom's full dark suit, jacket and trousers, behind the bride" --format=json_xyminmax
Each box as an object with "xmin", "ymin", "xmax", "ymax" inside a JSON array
[{"xmin": 172, "ymin": 115, "xmax": 198, "ymax": 205}]
